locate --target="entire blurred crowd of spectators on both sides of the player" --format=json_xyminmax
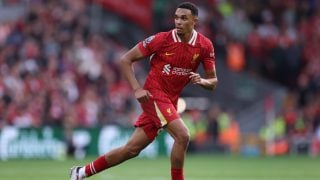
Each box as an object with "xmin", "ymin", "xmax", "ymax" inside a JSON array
[{"xmin": 0, "ymin": 0, "xmax": 320, "ymax": 155}]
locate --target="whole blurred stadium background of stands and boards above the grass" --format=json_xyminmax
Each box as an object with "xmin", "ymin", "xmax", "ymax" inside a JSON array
[{"xmin": 0, "ymin": 0, "xmax": 320, "ymax": 160}]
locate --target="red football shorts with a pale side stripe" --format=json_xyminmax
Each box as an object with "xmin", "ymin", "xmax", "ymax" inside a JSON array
[{"xmin": 134, "ymin": 98, "xmax": 180, "ymax": 141}]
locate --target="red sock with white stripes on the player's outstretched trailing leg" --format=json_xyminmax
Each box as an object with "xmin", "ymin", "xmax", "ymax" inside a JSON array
[{"xmin": 85, "ymin": 155, "xmax": 108, "ymax": 177}]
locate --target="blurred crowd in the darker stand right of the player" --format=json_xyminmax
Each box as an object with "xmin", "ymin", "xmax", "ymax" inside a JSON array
[{"xmin": 155, "ymin": 0, "xmax": 320, "ymax": 154}]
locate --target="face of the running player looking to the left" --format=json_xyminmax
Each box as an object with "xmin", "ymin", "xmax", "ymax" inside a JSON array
[{"xmin": 174, "ymin": 8, "xmax": 197, "ymax": 34}]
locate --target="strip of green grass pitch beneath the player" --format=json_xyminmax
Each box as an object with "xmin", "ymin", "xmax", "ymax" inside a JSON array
[{"xmin": 0, "ymin": 155, "xmax": 320, "ymax": 180}]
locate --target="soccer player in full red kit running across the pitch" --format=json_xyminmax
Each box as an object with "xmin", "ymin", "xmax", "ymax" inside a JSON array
[{"xmin": 70, "ymin": 2, "xmax": 218, "ymax": 180}]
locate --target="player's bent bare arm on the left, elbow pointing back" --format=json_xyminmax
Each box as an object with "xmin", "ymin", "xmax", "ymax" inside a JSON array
[{"xmin": 120, "ymin": 45, "xmax": 150, "ymax": 103}]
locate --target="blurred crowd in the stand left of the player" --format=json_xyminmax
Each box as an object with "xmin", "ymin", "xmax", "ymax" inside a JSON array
[{"xmin": 0, "ymin": 0, "xmax": 143, "ymax": 130}]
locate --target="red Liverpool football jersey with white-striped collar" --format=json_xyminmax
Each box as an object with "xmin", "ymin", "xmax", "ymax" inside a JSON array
[{"xmin": 138, "ymin": 29, "xmax": 215, "ymax": 106}]
